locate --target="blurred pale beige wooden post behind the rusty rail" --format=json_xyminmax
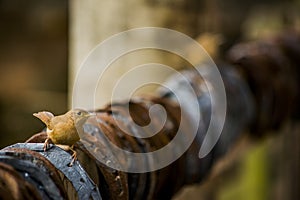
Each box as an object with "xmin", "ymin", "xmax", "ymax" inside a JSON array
[{"xmin": 69, "ymin": 0, "xmax": 207, "ymax": 107}]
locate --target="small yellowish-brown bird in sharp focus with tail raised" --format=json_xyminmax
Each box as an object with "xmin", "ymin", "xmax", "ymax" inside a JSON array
[{"xmin": 33, "ymin": 109, "xmax": 92, "ymax": 166}]
